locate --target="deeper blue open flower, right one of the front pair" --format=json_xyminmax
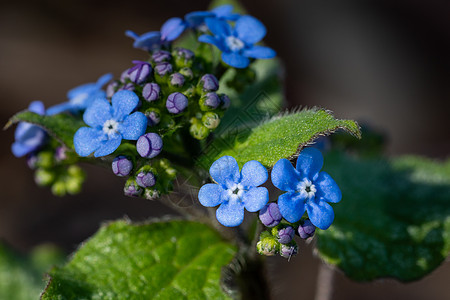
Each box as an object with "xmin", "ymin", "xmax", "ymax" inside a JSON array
[{"xmin": 272, "ymin": 148, "xmax": 342, "ymax": 229}]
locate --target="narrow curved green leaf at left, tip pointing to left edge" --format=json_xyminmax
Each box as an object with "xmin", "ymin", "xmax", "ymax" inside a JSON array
[{"xmin": 5, "ymin": 110, "xmax": 86, "ymax": 149}]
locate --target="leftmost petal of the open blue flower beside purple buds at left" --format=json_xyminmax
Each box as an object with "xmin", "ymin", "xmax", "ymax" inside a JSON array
[{"xmin": 73, "ymin": 127, "xmax": 105, "ymax": 157}]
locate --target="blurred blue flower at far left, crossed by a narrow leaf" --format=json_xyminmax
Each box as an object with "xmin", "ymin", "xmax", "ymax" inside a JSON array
[{"xmin": 11, "ymin": 101, "xmax": 47, "ymax": 157}]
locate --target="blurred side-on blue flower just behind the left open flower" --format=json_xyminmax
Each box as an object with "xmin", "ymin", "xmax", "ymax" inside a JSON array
[{"xmin": 47, "ymin": 74, "xmax": 112, "ymax": 115}]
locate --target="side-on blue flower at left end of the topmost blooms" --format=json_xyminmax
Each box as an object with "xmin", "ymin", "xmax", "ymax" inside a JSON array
[{"xmin": 125, "ymin": 18, "xmax": 187, "ymax": 51}]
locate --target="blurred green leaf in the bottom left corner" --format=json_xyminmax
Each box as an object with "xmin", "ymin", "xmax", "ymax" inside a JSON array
[{"xmin": 0, "ymin": 244, "xmax": 61, "ymax": 300}]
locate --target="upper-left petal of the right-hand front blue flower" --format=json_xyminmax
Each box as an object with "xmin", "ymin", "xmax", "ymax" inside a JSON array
[{"xmin": 271, "ymin": 158, "xmax": 300, "ymax": 191}]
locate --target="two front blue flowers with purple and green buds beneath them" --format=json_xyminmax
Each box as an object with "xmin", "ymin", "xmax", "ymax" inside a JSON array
[{"xmin": 198, "ymin": 148, "xmax": 342, "ymax": 257}]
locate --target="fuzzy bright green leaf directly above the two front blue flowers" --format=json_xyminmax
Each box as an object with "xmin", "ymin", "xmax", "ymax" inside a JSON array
[{"xmin": 198, "ymin": 109, "xmax": 361, "ymax": 169}]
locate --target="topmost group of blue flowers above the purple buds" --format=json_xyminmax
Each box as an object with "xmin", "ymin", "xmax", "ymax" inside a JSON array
[{"xmin": 125, "ymin": 5, "xmax": 276, "ymax": 69}]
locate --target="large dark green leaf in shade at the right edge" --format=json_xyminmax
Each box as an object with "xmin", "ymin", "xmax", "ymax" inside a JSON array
[{"xmin": 316, "ymin": 153, "xmax": 450, "ymax": 281}]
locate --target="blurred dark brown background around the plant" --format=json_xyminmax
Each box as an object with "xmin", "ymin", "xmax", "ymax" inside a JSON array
[{"xmin": 0, "ymin": 0, "xmax": 450, "ymax": 300}]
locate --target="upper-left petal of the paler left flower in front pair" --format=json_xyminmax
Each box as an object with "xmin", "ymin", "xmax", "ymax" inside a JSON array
[{"xmin": 209, "ymin": 156, "xmax": 241, "ymax": 187}]
